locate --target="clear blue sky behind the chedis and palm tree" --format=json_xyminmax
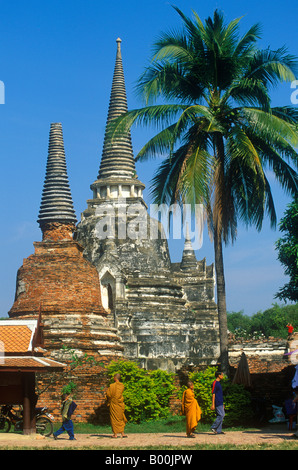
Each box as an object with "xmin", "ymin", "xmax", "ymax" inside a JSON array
[{"xmin": 0, "ymin": 0, "xmax": 298, "ymax": 316}]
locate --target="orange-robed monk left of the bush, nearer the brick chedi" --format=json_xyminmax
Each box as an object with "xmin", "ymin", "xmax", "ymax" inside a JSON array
[{"xmin": 106, "ymin": 374, "xmax": 127, "ymax": 438}]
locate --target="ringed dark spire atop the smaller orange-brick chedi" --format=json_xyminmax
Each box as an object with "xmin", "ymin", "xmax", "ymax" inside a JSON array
[{"xmin": 38, "ymin": 123, "xmax": 77, "ymax": 230}]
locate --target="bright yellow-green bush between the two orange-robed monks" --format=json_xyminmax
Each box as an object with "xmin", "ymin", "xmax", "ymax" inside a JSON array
[{"xmin": 107, "ymin": 360, "xmax": 175, "ymax": 423}]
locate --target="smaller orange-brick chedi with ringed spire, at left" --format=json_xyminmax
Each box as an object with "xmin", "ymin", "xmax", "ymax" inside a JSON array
[{"xmin": 9, "ymin": 123, "xmax": 123, "ymax": 361}]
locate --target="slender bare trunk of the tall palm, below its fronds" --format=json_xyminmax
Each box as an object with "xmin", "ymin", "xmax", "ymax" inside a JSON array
[{"xmin": 214, "ymin": 229, "xmax": 229, "ymax": 376}]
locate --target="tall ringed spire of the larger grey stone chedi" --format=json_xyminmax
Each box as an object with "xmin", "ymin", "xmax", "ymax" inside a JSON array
[{"xmin": 98, "ymin": 38, "xmax": 136, "ymax": 179}]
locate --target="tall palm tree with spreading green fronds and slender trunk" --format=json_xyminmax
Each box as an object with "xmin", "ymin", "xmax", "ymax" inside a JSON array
[{"xmin": 110, "ymin": 7, "xmax": 298, "ymax": 372}]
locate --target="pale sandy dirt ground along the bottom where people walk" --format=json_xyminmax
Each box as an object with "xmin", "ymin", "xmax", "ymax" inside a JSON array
[{"xmin": 0, "ymin": 426, "xmax": 298, "ymax": 450}]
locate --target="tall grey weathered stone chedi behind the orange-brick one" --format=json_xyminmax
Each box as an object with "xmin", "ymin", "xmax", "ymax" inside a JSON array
[{"xmin": 76, "ymin": 39, "xmax": 219, "ymax": 370}]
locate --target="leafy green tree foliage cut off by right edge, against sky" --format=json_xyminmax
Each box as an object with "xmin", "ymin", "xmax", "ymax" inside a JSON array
[{"xmin": 276, "ymin": 196, "xmax": 298, "ymax": 302}]
